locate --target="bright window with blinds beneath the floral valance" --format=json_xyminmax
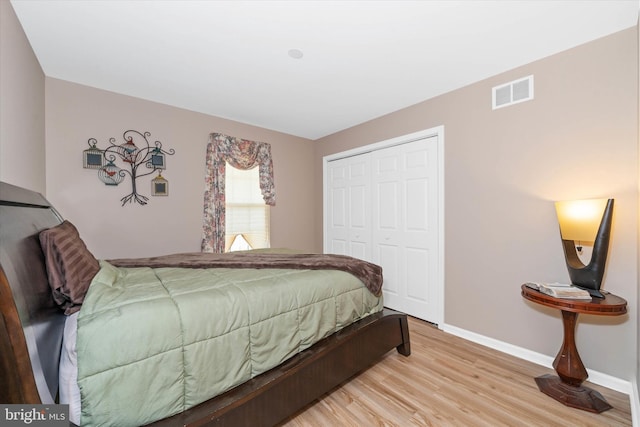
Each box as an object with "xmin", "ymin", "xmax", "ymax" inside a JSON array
[{"xmin": 225, "ymin": 163, "xmax": 270, "ymax": 252}]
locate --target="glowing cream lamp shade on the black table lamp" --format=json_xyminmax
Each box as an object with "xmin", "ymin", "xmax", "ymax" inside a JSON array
[{"xmin": 556, "ymin": 199, "xmax": 607, "ymax": 242}]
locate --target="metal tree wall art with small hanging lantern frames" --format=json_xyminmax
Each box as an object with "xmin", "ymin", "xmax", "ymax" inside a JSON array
[{"xmin": 83, "ymin": 130, "xmax": 175, "ymax": 206}]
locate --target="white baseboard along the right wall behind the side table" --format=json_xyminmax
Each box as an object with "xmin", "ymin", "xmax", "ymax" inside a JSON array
[{"xmin": 440, "ymin": 324, "xmax": 638, "ymax": 396}]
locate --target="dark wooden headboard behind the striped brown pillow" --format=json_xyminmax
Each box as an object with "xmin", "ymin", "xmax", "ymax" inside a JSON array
[{"xmin": 0, "ymin": 182, "xmax": 65, "ymax": 404}]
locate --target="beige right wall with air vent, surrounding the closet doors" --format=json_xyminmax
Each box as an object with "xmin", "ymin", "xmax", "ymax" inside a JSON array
[{"xmin": 315, "ymin": 28, "xmax": 638, "ymax": 380}]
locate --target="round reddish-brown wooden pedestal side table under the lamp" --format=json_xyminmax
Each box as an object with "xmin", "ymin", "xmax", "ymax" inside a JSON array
[{"xmin": 521, "ymin": 285, "xmax": 627, "ymax": 413}]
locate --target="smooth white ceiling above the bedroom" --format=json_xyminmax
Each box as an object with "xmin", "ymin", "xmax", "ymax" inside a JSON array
[{"xmin": 12, "ymin": 0, "xmax": 639, "ymax": 140}]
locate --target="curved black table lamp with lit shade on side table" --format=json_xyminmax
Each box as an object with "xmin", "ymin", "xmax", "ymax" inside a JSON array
[{"xmin": 556, "ymin": 199, "xmax": 613, "ymax": 298}]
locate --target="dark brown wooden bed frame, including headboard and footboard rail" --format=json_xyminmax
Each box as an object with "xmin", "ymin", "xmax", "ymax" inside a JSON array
[{"xmin": 0, "ymin": 182, "xmax": 411, "ymax": 426}]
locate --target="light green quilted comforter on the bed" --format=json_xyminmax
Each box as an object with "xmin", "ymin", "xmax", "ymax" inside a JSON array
[{"xmin": 77, "ymin": 261, "xmax": 382, "ymax": 427}]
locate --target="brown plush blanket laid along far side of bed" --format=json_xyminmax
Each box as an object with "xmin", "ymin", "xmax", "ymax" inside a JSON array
[{"xmin": 108, "ymin": 252, "xmax": 382, "ymax": 296}]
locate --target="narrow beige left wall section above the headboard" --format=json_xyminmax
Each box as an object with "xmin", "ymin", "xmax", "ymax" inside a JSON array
[{"xmin": 0, "ymin": 0, "xmax": 46, "ymax": 194}]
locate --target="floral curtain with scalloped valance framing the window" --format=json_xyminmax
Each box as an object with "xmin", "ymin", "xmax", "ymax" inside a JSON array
[{"xmin": 201, "ymin": 133, "xmax": 276, "ymax": 253}]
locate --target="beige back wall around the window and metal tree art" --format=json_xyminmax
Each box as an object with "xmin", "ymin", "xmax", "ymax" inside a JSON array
[{"xmin": 46, "ymin": 78, "xmax": 315, "ymax": 258}]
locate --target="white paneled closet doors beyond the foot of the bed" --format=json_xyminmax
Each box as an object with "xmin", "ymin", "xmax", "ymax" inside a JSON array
[{"xmin": 325, "ymin": 136, "xmax": 439, "ymax": 322}]
